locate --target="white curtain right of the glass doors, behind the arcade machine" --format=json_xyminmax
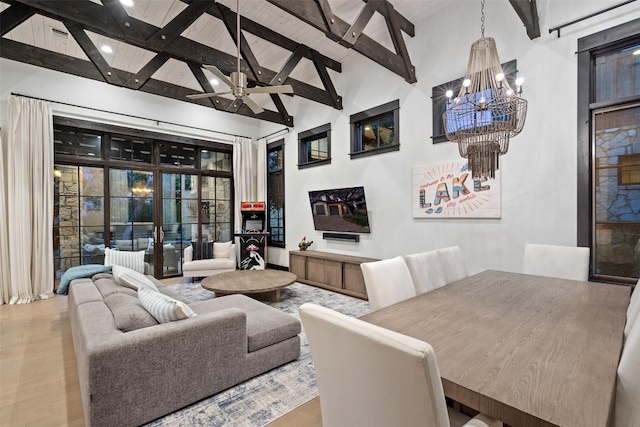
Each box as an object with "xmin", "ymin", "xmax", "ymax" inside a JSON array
[{"xmin": 233, "ymin": 136, "xmax": 256, "ymax": 231}]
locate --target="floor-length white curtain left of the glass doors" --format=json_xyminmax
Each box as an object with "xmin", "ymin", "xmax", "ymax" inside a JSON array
[{"xmin": 2, "ymin": 96, "xmax": 54, "ymax": 304}]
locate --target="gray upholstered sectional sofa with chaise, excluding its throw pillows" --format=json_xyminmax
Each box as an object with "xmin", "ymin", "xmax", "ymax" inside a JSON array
[{"xmin": 68, "ymin": 273, "xmax": 300, "ymax": 426}]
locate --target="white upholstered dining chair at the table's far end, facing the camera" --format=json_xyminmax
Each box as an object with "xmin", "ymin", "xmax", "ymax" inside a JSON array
[{"xmin": 522, "ymin": 243, "xmax": 590, "ymax": 281}]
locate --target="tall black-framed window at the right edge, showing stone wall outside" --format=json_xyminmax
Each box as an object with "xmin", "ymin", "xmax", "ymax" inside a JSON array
[{"xmin": 577, "ymin": 19, "xmax": 640, "ymax": 283}]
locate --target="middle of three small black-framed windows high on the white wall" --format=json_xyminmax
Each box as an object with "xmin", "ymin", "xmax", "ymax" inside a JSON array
[{"xmin": 349, "ymin": 100, "xmax": 400, "ymax": 159}]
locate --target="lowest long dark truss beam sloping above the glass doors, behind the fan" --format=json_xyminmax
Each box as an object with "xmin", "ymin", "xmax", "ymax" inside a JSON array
[{"xmin": 2, "ymin": 39, "xmax": 293, "ymax": 126}]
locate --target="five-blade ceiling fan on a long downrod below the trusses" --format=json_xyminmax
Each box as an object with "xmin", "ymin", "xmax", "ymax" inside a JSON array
[{"xmin": 187, "ymin": 0, "xmax": 293, "ymax": 114}]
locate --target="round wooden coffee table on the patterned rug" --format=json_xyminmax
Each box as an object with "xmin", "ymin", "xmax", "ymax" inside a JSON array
[{"xmin": 201, "ymin": 269, "xmax": 298, "ymax": 302}]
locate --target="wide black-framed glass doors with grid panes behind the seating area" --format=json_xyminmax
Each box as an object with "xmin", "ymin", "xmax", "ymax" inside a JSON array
[{"xmin": 53, "ymin": 117, "xmax": 233, "ymax": 283}]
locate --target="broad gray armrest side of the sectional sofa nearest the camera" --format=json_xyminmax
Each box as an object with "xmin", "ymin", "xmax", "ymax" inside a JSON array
[{"xmin": 74, "ymin": 308, "xmax": 248, "ymax": 426}]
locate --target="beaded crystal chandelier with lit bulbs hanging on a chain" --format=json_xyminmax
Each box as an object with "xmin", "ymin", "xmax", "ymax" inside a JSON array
[{"xmin": 443, "ymin": 0, "xmax": 527, "ymax": 178}]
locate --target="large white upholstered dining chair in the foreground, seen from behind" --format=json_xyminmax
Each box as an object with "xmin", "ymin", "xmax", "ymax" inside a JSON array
[{"xmin": 300, "ymin": 303, "xmax": 502, "ymax": 427}]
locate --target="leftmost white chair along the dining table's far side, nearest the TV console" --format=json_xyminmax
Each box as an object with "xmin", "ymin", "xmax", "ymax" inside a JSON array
[{"xmin": 360, "ymin": 256, "xmax": 416, "ymax": 311}]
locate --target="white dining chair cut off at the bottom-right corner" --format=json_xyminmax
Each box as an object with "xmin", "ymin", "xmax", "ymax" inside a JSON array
[{"xmin": 613, "ymin": 300, "xmax": 640, "ymax": 427}]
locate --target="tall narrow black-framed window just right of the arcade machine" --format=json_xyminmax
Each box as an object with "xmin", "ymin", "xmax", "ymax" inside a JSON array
[{"xmin": 267, "ymin": 139, "xmax": 285, "ymax": 248}]
